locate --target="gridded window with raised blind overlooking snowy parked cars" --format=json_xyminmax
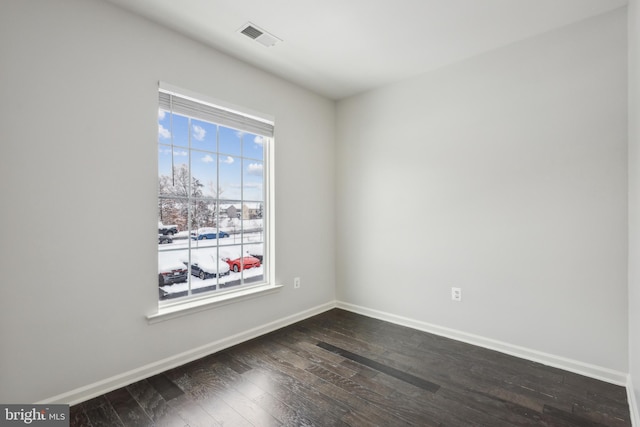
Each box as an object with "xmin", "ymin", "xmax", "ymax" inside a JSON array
[{"xmin": 158, "ymin": 84, "xmax": 273, "ymax": 304}]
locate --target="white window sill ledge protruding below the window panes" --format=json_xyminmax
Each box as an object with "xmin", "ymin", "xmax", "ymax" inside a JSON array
[{"xmin": 147, "ymin": 284, "xmax": 282, "ymax": 324}]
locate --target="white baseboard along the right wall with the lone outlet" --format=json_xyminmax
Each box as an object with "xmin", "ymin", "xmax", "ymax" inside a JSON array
[{"xmin": 336, "ymin": 301, "xmax": 628, "ymax": 386}]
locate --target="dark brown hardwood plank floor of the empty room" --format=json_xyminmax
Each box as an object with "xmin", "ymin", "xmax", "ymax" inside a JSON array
[{"xmin": 71, "ymin": 309, "xmax": 631, "ymax": 427}]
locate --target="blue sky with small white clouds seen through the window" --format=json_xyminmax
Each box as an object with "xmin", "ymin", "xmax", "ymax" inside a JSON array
[{"xmin": 158, "ymin": 110, "xmax": 264, "ymax": 200}]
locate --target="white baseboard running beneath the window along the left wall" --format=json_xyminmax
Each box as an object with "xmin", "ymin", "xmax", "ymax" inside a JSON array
[{"xmin": 37, "ymin": 301, "xmax": 336, "ymax": 405}]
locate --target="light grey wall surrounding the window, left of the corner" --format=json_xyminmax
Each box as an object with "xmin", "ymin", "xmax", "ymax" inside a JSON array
[{"xmin": 0, "ymin": 0, "xmax": 335, "ymax": 403}]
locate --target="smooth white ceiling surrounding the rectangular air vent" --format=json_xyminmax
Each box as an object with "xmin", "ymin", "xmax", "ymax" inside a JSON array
[{"xmin": 102, "ymin": 0, "xmax": 627, "ymax": 99}]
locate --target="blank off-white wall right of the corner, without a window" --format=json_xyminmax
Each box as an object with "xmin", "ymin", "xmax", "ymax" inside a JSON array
[{"xmin": 336, "ymin": 9, "xmax": 627, "ymax": 373}]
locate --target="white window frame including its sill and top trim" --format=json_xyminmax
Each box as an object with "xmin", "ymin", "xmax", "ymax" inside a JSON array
[{"xmin": 147, "ymin": 82, "xmax": 282, "ymax": 323}]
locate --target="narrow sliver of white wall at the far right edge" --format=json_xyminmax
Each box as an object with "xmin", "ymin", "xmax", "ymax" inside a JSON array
[{"xmin": 628, "ymin": 0, "xmax": 640, "ymax": 422}]
